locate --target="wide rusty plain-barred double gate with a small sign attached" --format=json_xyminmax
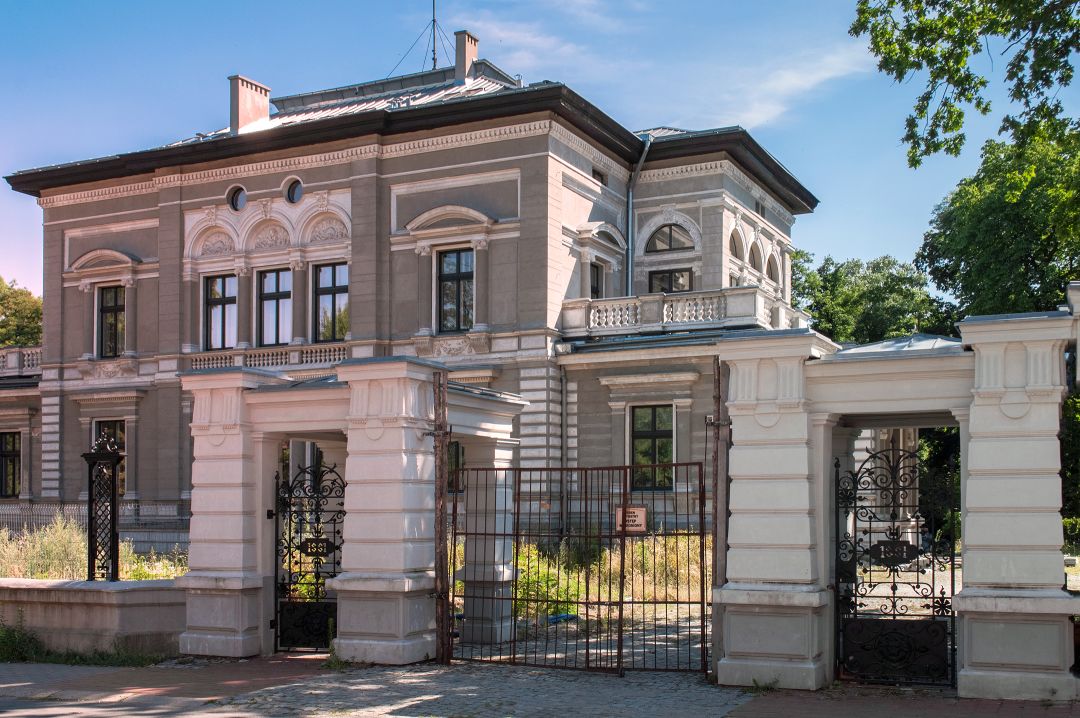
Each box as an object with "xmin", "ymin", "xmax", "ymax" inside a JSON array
[{"xmin": 447, "ymin": 463, "xmax": 713, "ymax": 674}]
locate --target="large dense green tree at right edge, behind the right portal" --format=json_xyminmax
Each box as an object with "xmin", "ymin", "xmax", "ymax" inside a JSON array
[{"xmin": 915, "ymin": 126, "xmax": 1080, "ymax": 314}]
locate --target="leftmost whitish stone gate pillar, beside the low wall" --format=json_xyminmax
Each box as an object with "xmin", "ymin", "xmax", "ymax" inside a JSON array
[{"xmin": 176, "ymin": 368, "xmax": 285, "ymax": 658}]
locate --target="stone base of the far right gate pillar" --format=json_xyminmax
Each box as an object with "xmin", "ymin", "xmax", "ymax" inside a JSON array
[{"xmin": 954, "ymin": 588, "xmax": 1080, "ymax": 701}]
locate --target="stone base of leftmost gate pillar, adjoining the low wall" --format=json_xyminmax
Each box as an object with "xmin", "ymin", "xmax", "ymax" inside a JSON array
[{"xmin": 176, "ymin": 573, "xmax": 264, "ymax": 658}]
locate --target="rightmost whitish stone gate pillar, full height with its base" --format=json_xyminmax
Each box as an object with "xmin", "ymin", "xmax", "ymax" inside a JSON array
[{"xmin": 955, "ymin": 313, "xmax": 1080, "ymax": 701}]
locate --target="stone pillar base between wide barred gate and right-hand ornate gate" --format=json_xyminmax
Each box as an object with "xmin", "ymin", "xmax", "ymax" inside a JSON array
[{"xmin": 713, "ymin": 584, "xmax": 832, "ymax": 690}]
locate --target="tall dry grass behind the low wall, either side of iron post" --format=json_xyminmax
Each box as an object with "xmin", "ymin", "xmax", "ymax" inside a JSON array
[{"xmin": 0, "ymin": 516, "xmax": 188, "ymax": 581}]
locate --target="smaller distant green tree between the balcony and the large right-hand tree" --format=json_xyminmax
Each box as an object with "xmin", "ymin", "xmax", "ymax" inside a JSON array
[{"xmin": 792, "ymin": 255, "xmax": 953, "ymax": 343}]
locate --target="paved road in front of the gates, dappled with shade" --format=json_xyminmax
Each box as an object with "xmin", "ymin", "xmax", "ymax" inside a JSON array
[{"xmin": 0, "ymin": 655, "xmax": 1080, "ymax": 718}]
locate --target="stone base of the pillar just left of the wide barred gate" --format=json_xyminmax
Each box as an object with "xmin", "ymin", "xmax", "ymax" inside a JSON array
[{"xmin": 326, "ymin": 572, "xmax": 435, "ymax": 665}]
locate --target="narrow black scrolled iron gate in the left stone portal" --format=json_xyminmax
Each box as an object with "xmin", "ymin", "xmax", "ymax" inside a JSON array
[{"xmin": 274, "ymin": 452, "xmax": 345, "ymax": 650}]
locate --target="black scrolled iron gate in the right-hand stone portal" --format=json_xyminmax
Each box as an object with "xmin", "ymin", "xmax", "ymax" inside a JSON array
[{"xmin": 836, "ymin": 449, "xmax": 959, "ymax": 686}]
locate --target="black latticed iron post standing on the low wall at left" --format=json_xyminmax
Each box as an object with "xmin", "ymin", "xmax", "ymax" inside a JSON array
[{"xmin": 82, "ymin": 433, "xmax": 123, "ymax": 581}]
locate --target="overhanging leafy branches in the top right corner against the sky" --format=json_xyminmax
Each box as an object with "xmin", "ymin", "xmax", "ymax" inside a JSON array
[{"xmin": 849, "ymin": 0, "xmax": 1080, "ymax": 167}]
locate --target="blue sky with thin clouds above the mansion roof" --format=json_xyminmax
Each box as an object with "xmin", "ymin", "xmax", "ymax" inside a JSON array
[{"xmin": 0, "ymin": 0, "xmax": 1077, "ymax": 292}]
